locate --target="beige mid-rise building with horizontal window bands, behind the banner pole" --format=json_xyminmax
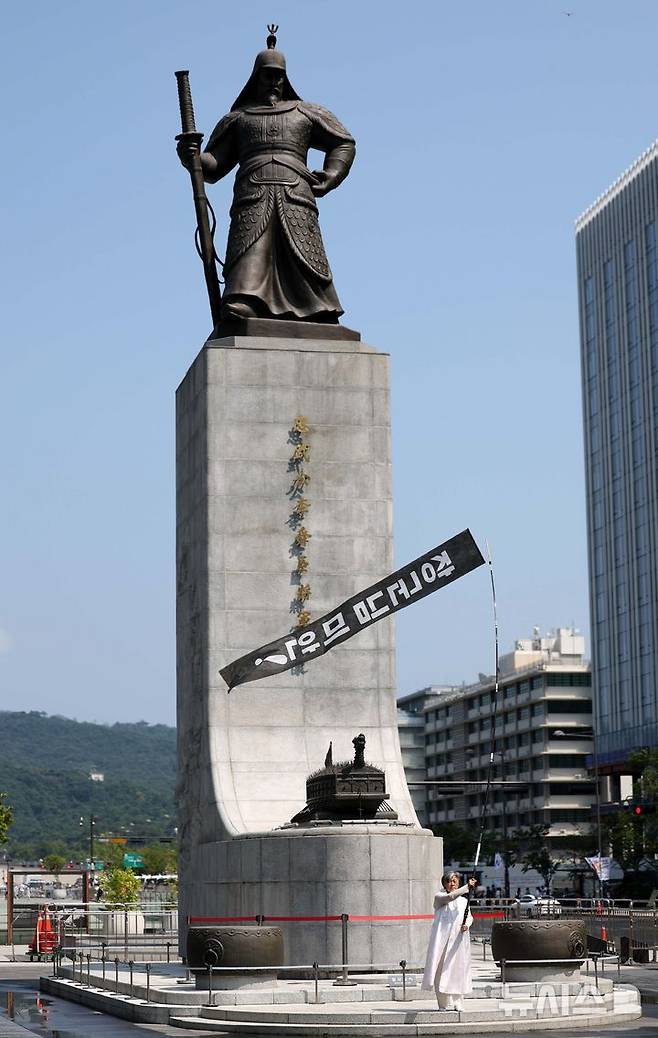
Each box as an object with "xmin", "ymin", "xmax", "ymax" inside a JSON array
[{"xmin": 415, "ymin": 628, "xmax": 595, "ymax": 839}]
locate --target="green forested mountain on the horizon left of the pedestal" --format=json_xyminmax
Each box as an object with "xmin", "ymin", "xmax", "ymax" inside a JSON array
[{"xmin": 0, "ymin": 711, "xmax": 176, "ymax": 859}]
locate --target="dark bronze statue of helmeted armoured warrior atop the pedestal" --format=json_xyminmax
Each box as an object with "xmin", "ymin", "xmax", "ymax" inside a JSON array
[{"xmin": 177, "ymin": 26, "xmax": 355, "ymax": 324}]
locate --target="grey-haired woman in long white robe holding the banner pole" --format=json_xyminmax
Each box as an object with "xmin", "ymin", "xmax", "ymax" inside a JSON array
[{"xmin": 421, "ymin": 872, "xmax": 477, "ymax": 1009}]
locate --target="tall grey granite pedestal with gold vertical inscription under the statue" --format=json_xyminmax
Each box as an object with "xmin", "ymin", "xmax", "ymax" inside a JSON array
[{"xmin": 176, "ymin": 334, "xmax": 440, "ymax": 961}]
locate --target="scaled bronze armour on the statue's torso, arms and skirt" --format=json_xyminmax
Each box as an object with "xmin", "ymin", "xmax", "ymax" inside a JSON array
[{"xmin": 208, "ymin": 101, "xmax": 354, "ymax": 319}]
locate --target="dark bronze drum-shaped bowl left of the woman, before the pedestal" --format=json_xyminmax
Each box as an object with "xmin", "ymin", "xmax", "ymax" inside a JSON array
[{"xmin": 187, "ymin": 925, "xmax": 283, "ymax": 971}]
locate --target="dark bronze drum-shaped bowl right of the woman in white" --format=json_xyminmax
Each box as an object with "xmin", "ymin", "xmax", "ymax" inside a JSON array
[{"xmin": 491, "ymin": 919, "xmax": 587, "ymax": 962}]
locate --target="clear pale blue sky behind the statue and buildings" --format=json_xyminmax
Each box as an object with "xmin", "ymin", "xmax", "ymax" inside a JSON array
[{"xmin": 0, "ymin": 0, "xmax": 658, "ymax": 722}]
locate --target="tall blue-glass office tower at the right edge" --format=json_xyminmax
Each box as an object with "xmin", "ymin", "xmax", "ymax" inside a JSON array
[{"xmin": 576, "ymin": 142, "xmax": 658, "ymax": 769}]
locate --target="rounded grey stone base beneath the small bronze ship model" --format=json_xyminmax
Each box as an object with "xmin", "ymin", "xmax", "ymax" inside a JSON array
[{"xmin": 182, "ymin": 823, "xmax": 442, "ymax": 966}]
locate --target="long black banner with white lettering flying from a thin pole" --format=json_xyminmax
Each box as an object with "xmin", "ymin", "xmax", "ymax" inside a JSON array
[{"xmin": 219, "ymin": 529, "xmax": 485, "ymax": 691}]
